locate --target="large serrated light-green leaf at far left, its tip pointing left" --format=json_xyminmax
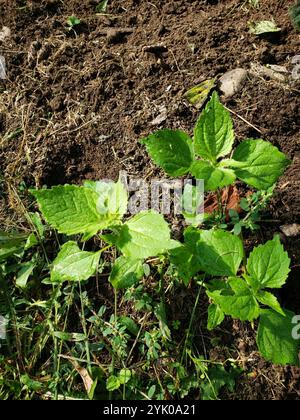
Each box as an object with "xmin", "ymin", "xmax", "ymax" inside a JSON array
[{"xmin": 31, "ymin": 185, "xmax": 112, "ymax": 236}]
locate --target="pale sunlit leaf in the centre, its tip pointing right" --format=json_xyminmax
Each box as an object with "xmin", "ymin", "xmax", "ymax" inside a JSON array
[{"xmin": 107, "ymin": 211, "xmax": 178, "ymax": 260}]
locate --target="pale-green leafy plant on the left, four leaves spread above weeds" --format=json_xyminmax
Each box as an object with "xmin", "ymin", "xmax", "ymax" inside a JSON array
[{"xmin": 32, "ymin": 181, "xmax": 177, "ymax": 288}]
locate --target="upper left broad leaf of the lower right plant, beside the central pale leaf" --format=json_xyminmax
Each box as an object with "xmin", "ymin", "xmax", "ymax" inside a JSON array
[{"xmin": 197, "ymin": 230, "xmax": 244, "ymax": 276}]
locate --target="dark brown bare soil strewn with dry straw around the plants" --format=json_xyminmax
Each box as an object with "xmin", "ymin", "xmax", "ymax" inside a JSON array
[{"xmin": 0, "ymin": 0, "xmax": 300, "ymax": 399}]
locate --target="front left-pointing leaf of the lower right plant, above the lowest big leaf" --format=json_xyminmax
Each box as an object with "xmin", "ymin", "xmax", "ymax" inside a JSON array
[{"xmin": 207, "ymin": 278, "xmax": 260, "ymax": 321}]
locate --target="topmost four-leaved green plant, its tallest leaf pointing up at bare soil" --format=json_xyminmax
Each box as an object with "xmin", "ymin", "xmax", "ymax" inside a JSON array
[{"xmin": 141, "ymin": 92, "xmax": 289, "ymax": 191}]
